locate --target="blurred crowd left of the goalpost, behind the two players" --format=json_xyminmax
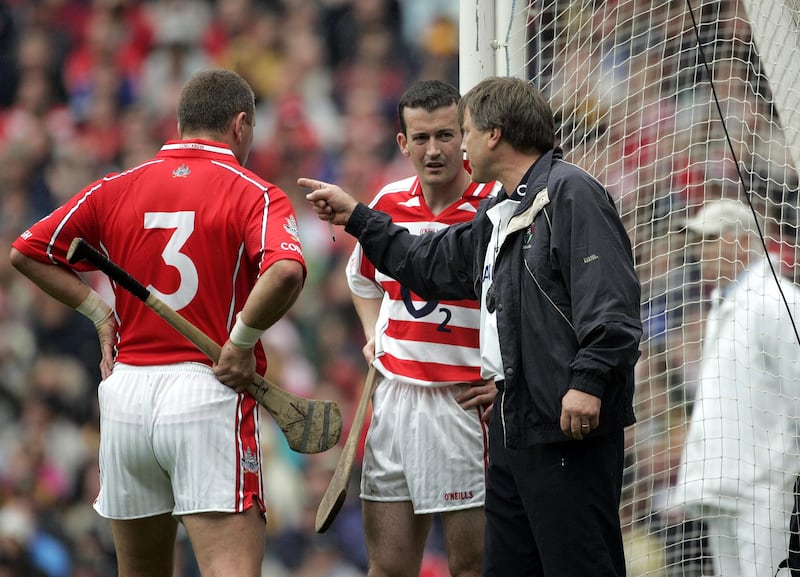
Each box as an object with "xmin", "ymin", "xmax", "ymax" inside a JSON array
[{"xmin": 0, "ymin": 0, "xmax": 458, "ymax": 577}]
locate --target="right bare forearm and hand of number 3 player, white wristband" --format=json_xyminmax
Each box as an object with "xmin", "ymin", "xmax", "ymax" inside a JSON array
[{"xmin": 214, "ymin": 260, "xmax": 305, "ymax": 393}]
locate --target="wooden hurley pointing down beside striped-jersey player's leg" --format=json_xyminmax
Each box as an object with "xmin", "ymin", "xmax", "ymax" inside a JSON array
[{"xmin": 316, "ymin": 365, "xmax": 375, "ymax": 533}]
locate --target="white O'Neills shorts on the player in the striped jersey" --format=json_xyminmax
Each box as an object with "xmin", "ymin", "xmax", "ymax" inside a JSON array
[{"xmin": 361, "ymin": 378, "xmax": 487, "ymax": 514}]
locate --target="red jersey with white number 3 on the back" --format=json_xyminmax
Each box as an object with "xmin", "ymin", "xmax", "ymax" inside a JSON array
[{"xmin": 13, "ymin": 140, "xmax": 305, "ymax": 373}]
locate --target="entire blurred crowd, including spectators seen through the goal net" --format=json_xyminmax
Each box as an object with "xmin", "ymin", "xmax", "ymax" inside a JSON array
[{"xmin": 0, "ymin": 0, "xmax": 796, "ymax": 577}]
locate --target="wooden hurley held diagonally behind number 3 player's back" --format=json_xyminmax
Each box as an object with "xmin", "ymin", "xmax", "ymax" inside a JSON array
[{"xmin": 67, "ymin": 238, "xmax": 342, "ymax": 453}]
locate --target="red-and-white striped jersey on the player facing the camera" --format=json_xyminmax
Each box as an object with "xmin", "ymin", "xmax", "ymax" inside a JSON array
[{"xmin": 347, "ymin": 177, "xmax": 500, "ymax": 386}]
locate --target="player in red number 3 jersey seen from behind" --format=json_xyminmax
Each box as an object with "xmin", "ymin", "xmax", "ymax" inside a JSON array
[{"xmin": 11, "ymin": 70, "xmax": 306, "ymax": 577}]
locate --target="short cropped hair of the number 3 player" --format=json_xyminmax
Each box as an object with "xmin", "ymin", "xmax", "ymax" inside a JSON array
[{"xmin": 178, "ymin": 68, "xmax": 255, "ymax": 134}]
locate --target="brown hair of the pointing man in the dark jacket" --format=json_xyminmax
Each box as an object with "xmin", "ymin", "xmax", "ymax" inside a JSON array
[{"xmin": 458, "ymin": 76, "xmax": 556, "ymax": 153}]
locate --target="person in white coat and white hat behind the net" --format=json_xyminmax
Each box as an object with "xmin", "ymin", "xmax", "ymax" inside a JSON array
[{"xmin": 676, "ymin": 198, "xmax": 800, "ymax": 577}]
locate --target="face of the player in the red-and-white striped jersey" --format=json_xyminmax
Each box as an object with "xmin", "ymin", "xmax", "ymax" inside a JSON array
[{"xmin": 397, "ymin": 104, "xmax": 464, "ymax": 186}]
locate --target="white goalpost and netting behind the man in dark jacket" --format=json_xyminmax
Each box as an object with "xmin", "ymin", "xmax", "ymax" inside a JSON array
[{"xmin": 459, "ymin": 0, "xmax": 800, "ymax": 577}]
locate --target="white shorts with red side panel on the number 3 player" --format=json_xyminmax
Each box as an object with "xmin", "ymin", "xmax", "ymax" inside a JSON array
[{"xmin": 94, "ymin": 363, "xmax": 266, "ymax": 519}]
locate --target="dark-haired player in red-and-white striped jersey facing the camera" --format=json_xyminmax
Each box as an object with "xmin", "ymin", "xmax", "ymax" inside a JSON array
[{"xmin": 347, "ymin": 80, "xmax": 499, "ymax": 577}]
